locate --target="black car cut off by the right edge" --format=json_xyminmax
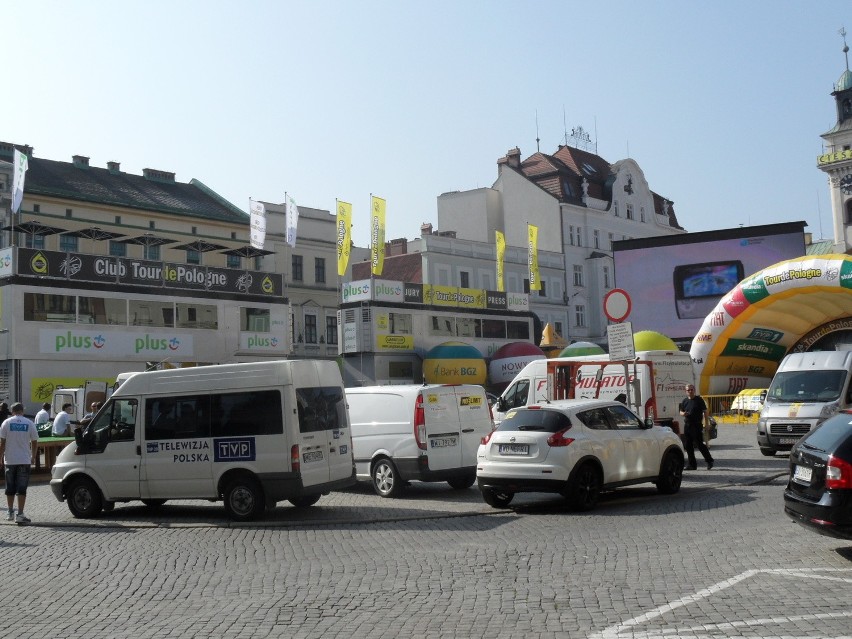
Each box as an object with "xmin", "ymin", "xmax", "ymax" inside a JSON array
[{"xmin": 784, "ymin": 410, "xmax": 852, "ymax": 539}]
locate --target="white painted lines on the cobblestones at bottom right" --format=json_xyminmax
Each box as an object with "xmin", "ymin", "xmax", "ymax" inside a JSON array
[{"xmin": 589, "ymin": 568, "xmax": 852, "ymax": 639}]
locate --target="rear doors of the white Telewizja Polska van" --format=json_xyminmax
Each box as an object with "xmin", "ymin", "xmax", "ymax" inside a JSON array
[{"xmin": 292, "ymin": 361, "xmax": 352, "ymax": 487}]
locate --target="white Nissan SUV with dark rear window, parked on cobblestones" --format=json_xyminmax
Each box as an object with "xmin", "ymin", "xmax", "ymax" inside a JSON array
[{"xmin": 476, "ymin": 399, "xmax": 683, "ymax": 510}]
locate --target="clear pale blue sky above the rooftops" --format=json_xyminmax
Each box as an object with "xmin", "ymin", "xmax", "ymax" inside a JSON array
[{"xmin": 6, "ymin": 0, "xmax": 852, "ymax": 246}]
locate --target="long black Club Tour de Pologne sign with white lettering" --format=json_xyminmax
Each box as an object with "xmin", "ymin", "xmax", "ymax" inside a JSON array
[{"xmin": 16, "ymin": 248, "xmax": 284, "ymax": 298}]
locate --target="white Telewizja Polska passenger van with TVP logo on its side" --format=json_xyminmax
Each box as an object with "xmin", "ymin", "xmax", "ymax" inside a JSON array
[{"xmin": 50, "ymin": 360, "xmax": 355, "ymax": 521}]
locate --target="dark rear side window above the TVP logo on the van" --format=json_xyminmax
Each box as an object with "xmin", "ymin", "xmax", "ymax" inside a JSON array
[{"xmin": 210, "ymin": 390, "xmax": 284, "ymax": 437}]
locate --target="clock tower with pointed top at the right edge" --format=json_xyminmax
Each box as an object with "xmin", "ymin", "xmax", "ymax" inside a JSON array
[{"xmin": 817, "ymin": 29, "xmax": 852, "ymax": 253}]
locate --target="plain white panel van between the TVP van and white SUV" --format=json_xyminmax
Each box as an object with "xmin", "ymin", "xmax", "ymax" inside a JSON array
[{"xmin": 346, "ymin": 384, "xmax": 493, "ymax": 497}]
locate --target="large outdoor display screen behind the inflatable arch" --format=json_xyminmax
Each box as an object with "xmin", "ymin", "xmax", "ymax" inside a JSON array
[{"xmin": 613, "ymin": 222, "xmax": 806, "ymax": 341}]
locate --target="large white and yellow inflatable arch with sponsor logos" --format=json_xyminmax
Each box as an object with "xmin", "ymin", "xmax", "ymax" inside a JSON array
[{"xmin": 690, "ymin": 255, "xmax": 852, "ymax": 395}]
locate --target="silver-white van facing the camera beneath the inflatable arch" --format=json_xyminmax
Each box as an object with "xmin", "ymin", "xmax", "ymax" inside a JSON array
[{"xmin": 757, "ymin": 351, "xmax": 852, "ymax": 457}]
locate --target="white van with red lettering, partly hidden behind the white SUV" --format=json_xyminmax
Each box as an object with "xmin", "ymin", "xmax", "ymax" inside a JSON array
[{"xmin": 494, "ymin": 350, "xmax": 695, "ymax": 433}]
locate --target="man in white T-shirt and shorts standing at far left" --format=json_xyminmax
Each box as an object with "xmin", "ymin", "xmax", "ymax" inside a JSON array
[{"xmin": 0, "ymin": 402, "xmax": 38, "ymax": 525}]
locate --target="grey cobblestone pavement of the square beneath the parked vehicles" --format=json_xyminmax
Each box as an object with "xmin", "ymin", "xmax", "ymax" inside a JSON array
[{"xmin": 0, "ymin": 425, "xmax": 852, "ymax": 639}]
